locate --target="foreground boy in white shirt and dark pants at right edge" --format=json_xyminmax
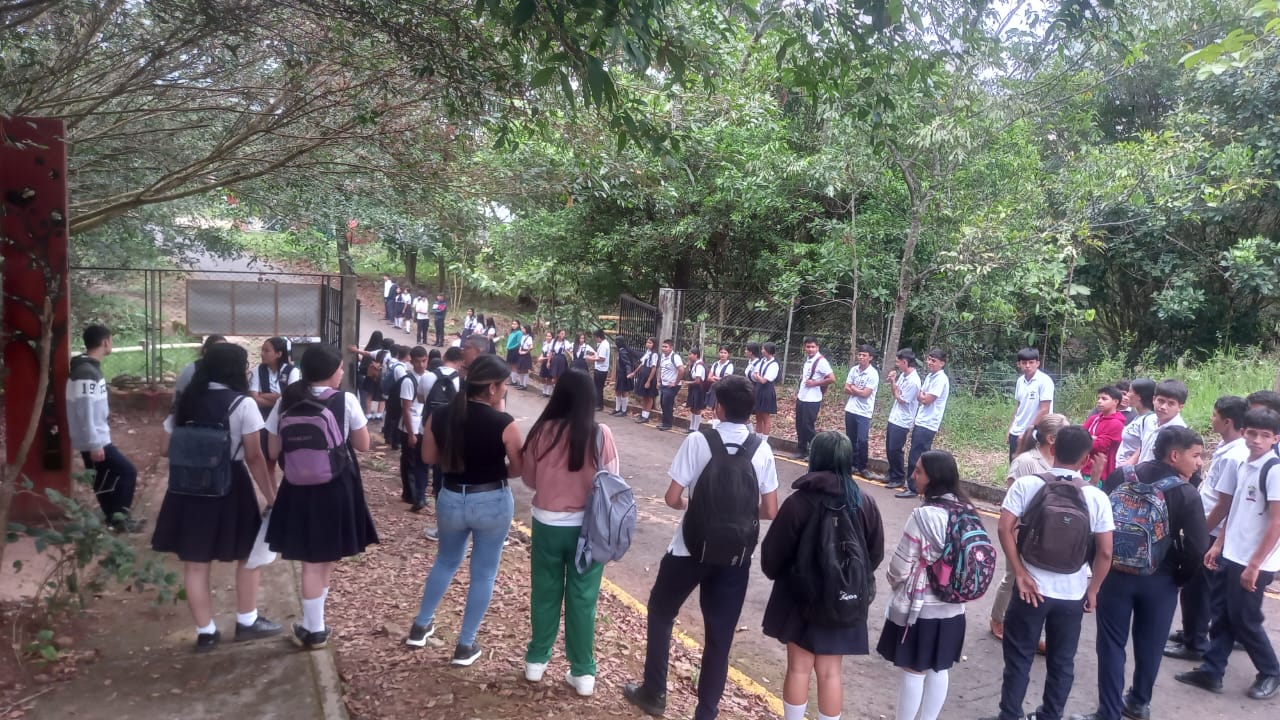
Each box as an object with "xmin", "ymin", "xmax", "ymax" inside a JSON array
[{"xmin": 1174, "ymin": 409, "xmax": 1280, "ymax": 700}]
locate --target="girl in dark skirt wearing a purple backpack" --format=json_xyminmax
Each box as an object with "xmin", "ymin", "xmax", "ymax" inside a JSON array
[{"xmin": 266, "ymin": 345, "xmax": 378, "ymax": 650}]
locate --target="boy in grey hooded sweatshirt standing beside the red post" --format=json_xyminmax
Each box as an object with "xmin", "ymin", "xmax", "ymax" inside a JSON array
[{"xmin": 67, "ymin": 325, "xmax": 146, "ymax": 533}]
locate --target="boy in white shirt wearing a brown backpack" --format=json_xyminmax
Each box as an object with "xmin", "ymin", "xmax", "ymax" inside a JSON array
[{"xmin": 998, "ymin": 425, "xmax": 1115, "ymax": 720}]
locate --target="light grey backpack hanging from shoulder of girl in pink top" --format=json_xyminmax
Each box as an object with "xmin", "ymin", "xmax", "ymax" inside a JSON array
[{"xmin": 573, "ymin": 427, "xmax": 636, "ymax": 574}]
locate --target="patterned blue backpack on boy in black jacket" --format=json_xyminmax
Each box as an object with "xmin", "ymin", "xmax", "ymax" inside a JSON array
[{"xmin": 1111, "ymin": 465, "xmax": 1181, "ymax": 575}]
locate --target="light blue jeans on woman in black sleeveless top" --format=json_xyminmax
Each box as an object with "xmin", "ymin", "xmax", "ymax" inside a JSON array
[{"xmin": 413, "ymin": 488, "xmax": 516, "ymax": 644}]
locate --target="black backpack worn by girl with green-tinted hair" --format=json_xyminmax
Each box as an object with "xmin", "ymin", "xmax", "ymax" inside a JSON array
[{"xmin": 788, "ymin": 496, "xmax": 876, "ymax": 628}]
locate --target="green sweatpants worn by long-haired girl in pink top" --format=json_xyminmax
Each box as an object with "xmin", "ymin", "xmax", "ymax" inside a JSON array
[{"xmin": 525, "ymin": 519, "xmax": 604, "ymax": 675}]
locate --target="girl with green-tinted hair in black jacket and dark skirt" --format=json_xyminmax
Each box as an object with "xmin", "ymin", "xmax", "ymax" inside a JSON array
[{"xmin": 760, "ymin": 432, "xmax": 884, "ymax": 720}]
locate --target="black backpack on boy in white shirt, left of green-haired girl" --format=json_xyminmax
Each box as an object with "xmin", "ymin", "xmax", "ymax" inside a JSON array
[{"xmin": 684, "ymin": 428, "xmax": 760, "ymax": 566}]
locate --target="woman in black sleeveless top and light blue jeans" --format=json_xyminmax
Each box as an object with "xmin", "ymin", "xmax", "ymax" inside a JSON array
[{"xmin": 404, "ymin": 355, "xmax": 522, "ymax": 666}]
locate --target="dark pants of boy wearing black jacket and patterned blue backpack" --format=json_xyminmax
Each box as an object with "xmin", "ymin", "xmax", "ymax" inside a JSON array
[{"xmin": 1097, "ymin": 573, "xmax": 1178, "ymax": 720}]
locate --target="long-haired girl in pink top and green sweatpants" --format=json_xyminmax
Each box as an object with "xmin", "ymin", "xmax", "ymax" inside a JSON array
[{"xmin": 521, "ymin": 370, "xmax": 618, "ymax": 696}]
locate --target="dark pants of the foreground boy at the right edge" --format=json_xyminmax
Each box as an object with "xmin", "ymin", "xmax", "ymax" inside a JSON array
[{"xmin": 1201, "ymin": 558, "xmax": 1280, "ymax": 678}]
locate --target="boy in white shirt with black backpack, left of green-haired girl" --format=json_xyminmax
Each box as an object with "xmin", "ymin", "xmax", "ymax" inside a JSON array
[{"xmin": 622, "ymin": 375, "xmax": 778, "ymax": 720}]
